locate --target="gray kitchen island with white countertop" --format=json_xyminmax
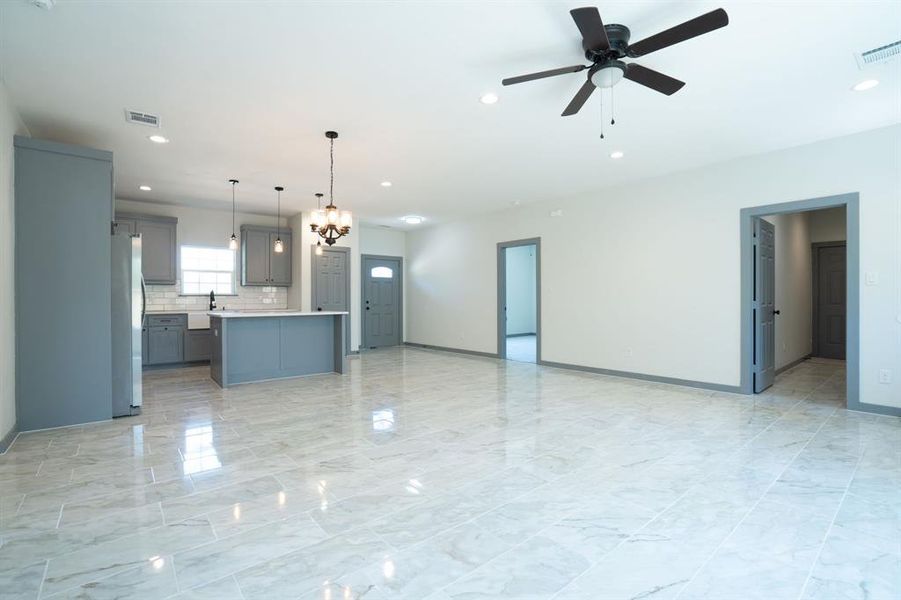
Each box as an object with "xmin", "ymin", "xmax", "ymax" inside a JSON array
[{"xmin": 208, "ymin": 310, "xmax": 347, "ymax": 387}]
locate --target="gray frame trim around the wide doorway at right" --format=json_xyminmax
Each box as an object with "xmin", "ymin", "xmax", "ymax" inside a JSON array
[{"xmin": 739, "ymin": 192, "xmax": 860, "ymax": 412}]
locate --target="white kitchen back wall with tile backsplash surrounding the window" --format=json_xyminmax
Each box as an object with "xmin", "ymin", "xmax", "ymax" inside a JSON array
[{"xmin": 116, "ymin": 199, "xmax": 286, "ymax": 311}]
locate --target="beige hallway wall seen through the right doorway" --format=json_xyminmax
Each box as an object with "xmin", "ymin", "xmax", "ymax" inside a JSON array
[{"xmin": 764, "ymin": 212, "xmax": 813, "ymax": 370}]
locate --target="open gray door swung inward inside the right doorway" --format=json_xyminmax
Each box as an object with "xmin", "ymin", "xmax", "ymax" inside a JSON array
[{"xmin": 751, "ymin": 219, "xmax": 777, "ymax": 393}]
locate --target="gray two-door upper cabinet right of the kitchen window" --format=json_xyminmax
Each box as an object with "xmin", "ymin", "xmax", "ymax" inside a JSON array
[{"xmin": 241, "ymin": 225, "xmax": 291, "ymax": 287}]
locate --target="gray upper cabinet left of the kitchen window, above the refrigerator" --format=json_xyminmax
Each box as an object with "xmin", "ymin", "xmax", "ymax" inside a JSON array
[{"xmin": 116, "ymin": 213, "xmax": 178, "ymax": 285}]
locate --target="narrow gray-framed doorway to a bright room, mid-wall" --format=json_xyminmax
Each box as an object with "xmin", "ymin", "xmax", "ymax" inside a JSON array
[{"xmin": 497, "ymin": 238, "xmax": 541, "ymax": 364}]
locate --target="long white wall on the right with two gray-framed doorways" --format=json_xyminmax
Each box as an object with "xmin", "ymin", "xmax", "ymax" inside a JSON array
[{"xmin": 407, "ymin": 125, "xmax": 901, "ymax": 407}]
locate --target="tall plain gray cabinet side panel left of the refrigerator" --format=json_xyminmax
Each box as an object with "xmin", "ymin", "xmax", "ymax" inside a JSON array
[{"xmin": 13, "ymin": 137, "xmax": 113, "ymax": 432}]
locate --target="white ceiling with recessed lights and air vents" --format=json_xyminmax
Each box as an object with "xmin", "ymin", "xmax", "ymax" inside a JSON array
[{"xmin": 0, "ymin": 0, "xmax": 901, "ymax": 226}]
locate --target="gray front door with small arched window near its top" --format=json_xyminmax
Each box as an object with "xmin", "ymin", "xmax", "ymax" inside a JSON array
[{"xmin": 363, "ymin": 256, "xmax": 402, "ymax": 348}]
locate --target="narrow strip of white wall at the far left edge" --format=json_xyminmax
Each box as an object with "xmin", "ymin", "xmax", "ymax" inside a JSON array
[{"xmin": 0, "ymin": 81, "xmax": 28, "ymax": 440}]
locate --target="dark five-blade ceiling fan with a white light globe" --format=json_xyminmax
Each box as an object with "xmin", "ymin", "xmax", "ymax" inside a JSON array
[{"xmin": 502, "ymin": 6, "xmax": 729, "ymax": 117}]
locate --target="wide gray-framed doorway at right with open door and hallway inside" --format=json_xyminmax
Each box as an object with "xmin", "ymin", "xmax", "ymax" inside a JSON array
[{"xmin": 741, "ymin": 194, "xmax": 863, "ymax": 409}]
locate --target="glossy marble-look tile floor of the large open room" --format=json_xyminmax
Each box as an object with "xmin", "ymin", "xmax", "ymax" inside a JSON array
[{"xmin": 0, "ymin": 348, "xmax": 901, "ymax": 600}]
